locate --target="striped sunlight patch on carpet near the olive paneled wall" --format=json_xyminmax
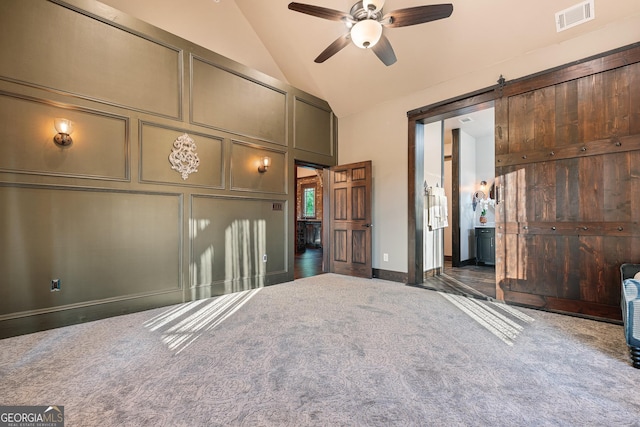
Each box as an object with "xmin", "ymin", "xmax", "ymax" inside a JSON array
[{"xmin": 144, "ymin": 288, "xmax": 262, "ymax": 354}]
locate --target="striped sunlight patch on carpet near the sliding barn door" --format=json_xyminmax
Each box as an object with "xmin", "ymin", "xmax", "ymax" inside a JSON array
[{"xmin": 438, "ymin": 292, "xmax": 534, "ymax": 346}]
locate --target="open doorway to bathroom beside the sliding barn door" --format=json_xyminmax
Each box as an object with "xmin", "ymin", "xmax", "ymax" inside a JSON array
[{"xmin": 416, "ymin": 103, "xmax": 496, "ymax": 298}]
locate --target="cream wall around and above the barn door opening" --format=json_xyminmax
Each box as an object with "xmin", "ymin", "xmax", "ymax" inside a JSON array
[{"xmin": 338, "ymin": 16, "xmax": 640, "ymax": 272}]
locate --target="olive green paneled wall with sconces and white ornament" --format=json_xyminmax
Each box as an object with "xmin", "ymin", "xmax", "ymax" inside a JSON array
[{"xmin": 0, "ymin": 0, "xmax": 337, "ymax": 337}]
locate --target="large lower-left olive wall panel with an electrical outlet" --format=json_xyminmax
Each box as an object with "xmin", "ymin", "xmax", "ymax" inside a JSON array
[{"xmin": 0, "ymin": 183, "xmax": 184, "ymax": 320}]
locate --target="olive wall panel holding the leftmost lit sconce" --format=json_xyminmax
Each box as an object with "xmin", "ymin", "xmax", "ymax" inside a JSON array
[{"xmin": 0, "ymin": 91, "xmax": 130, "ymax": 181}]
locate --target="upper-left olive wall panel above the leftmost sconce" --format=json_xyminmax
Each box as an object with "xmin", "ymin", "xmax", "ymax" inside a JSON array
[{"xmin": 0, "ymin": 0, "xmax": 183, "ymax": 119}]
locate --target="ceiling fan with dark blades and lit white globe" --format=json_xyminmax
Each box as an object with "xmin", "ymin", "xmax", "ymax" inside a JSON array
[{"xmin": 289, "ymin": 0, "xmax": 453, "ymax": 66}]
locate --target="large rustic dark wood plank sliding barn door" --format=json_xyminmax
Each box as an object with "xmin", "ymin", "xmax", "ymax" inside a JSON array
[{"xmin": 495, "ymin": 47, "xmax": 640, "ymax": 319}]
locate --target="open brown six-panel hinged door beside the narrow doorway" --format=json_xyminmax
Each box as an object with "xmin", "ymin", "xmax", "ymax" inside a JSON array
[{"xmin": 325, "ymin": 161, "xmax": 373, "ymax": 278}]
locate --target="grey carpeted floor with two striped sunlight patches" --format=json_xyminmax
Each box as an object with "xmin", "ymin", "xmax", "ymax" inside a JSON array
[{"xmin": 0, "ymin": 274, "xmax": 640, "ymax": 426}]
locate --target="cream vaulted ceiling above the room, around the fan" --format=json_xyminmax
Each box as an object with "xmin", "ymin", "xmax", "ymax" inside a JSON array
[{"xmin": 104, "ymin": 0, "xmax": 640, "ymax": 117}]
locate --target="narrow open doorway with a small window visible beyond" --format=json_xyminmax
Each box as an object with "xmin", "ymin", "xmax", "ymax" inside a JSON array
[{"xmin": 294, "ymin": 163, "xmax": 324, "ymax": 279}]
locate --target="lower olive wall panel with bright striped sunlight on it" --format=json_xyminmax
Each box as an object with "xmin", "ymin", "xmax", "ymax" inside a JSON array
[{"xmin": 189, "ymin": 194, "xmax": 293, "ymax": 299}]
